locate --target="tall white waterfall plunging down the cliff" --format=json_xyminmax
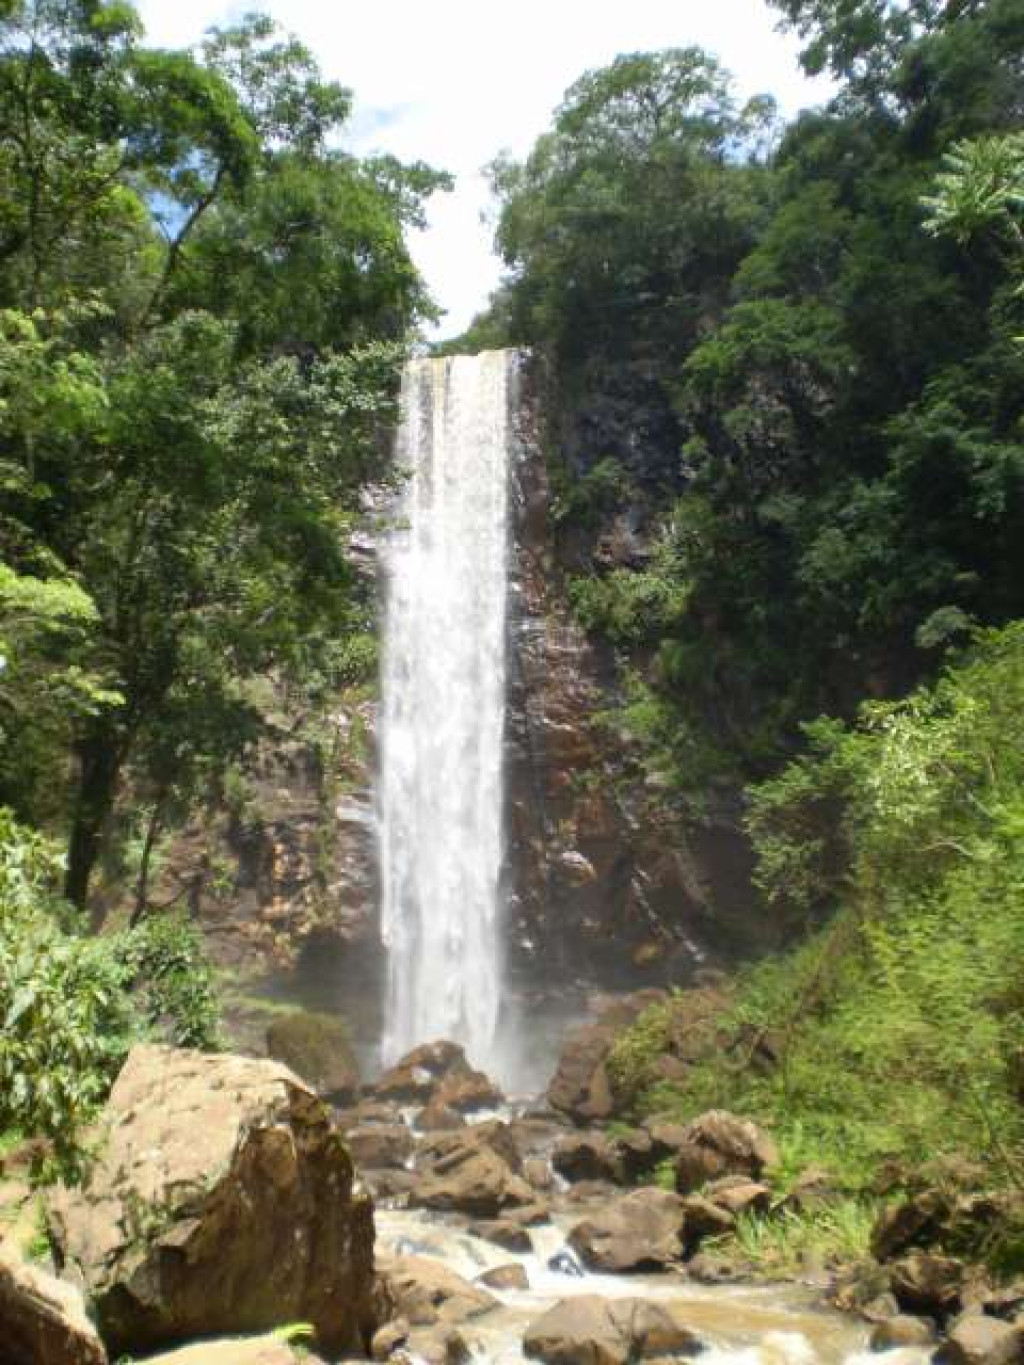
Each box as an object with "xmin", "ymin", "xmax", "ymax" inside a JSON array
[{"xmin": 378, "ymin": 351, "xmax": 516, "ymax": 1066}]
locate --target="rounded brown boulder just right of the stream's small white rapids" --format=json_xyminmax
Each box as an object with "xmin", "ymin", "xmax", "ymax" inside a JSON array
[{"xmin": 569, "ymin": 1186, "xmax": 687, "ymax": 1274}]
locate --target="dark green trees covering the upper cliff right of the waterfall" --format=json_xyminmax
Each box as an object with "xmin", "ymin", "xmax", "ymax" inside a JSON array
[{"xmin": 480, "ymin": 0, "xmax": 1024, "ymax": 794}]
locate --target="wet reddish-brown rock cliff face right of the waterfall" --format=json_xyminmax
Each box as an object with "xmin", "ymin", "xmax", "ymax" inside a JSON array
[{"xmin": 508, "ymin": 365, "xmax": 763, "ymax": 987}]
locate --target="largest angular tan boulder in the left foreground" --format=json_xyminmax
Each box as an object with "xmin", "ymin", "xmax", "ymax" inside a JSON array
[{"xmin": 49, "ymin": 1047, "xmax": 374, "ymax": 1355}]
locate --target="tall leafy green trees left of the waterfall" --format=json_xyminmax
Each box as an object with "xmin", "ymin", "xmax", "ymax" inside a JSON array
[{"xmin": 0, "ymin": 0, "xmax": 446, "ymax": 919}]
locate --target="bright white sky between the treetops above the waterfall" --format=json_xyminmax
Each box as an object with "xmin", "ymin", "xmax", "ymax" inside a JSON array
[{"xmin": 138, "ymin": 0, "xmax": 826, "ymax": 336}]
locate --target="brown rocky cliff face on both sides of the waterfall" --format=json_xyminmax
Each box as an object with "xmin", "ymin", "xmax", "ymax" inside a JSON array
[{"xmin": 174, "ymin": 354, "xmax": 765, "ymax": 1040}]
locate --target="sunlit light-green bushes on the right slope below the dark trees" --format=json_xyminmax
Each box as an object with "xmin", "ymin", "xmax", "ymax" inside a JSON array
[{"xmin": 614, "ymin": 625, "xmax": 1024, "ymax": 1186}]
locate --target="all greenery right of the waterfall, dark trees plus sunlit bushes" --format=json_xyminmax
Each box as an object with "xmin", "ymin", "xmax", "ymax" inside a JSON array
[{"xmin": 466, "ymin": 0, "xmax": 1024, "ymax": 1188}]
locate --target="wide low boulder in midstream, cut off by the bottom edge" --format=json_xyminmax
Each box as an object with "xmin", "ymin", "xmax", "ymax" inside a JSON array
[{"xmin": 523, "ymin": 1294, "xmax": 700, "ymax": 1365}]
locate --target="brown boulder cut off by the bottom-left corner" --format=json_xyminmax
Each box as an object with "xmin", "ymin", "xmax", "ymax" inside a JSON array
[{"xmin": 0, "ymin": 1248, "xmax": 106, "ymax": 1365}]
